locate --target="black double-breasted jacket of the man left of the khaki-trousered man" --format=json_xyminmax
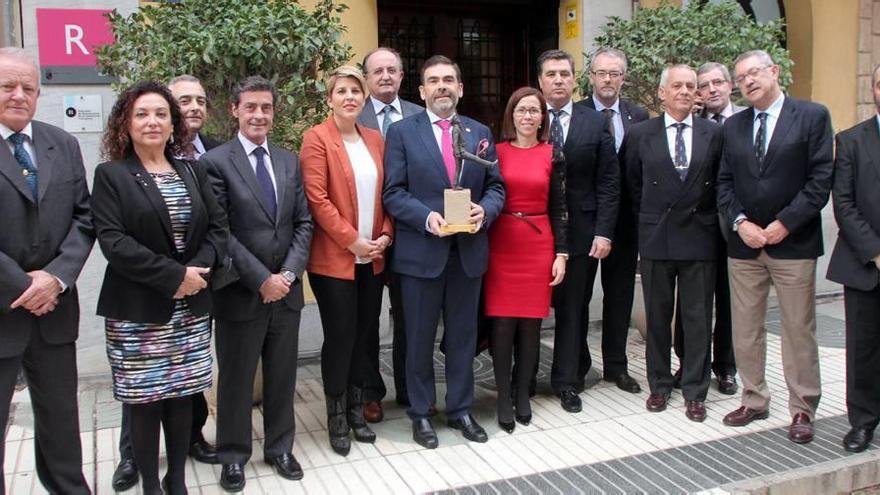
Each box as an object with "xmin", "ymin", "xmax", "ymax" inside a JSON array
[{"xmin": 621, "ymin": 115, "xmax": 721, "ymax": 260}]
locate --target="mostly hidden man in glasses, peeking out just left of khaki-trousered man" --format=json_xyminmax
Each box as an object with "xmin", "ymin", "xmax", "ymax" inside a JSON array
[{"xmin": 674, "ymin": 62, "xmax": 745, "ymax": 395}]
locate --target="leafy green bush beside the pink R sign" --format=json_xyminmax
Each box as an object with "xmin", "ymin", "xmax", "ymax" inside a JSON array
[{"xmin": 97, "ymin": 0, "xmax": 351, "ymax": 149}]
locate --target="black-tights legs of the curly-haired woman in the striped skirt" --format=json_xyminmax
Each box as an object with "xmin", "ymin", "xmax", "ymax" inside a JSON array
[{"xmin": 131, "ymin": 396, "xmax": 192, "ymax": 495}]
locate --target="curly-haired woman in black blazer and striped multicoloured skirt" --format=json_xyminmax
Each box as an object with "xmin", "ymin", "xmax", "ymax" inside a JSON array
[{"xmin": 92, "ymin": 82, "xmax": 226, "ymax": 494}]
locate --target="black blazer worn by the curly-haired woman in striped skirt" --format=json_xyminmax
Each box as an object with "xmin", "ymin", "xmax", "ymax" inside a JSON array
[{"xmin": 92, "ymin": 154, "xmax": 228, "ymax": 324}]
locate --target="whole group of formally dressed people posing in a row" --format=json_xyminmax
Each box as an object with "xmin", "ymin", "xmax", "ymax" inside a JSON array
[{"xmin": 0, "ymin": 38, "xmax": 880, "ymax": 494}]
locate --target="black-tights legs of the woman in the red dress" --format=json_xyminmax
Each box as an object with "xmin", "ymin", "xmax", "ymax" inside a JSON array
[{"xmin": 492, "ymin": 318, "xmax": 541, "ymax": 423}]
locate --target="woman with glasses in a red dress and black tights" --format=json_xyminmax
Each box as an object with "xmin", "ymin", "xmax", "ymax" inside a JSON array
[{"xmin": 484, "ymin": 87, "xmax": 568, "ymax": 433}]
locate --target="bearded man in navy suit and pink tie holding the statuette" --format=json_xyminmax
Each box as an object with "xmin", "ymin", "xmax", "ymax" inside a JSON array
[{"xmin": 382, "ymin": 55, "xmax": 504, "ymax": 449}]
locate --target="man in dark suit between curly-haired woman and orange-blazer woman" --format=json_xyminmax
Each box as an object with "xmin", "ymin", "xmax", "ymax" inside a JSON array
[{"xmin": 199, "ymin": 76, "xmax": 312, "ymax": 491}]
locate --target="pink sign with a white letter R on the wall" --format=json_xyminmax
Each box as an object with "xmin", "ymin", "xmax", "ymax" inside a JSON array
[{"xmin": 37, "ymin": 9, "xmax": 116, "ymax": 67}]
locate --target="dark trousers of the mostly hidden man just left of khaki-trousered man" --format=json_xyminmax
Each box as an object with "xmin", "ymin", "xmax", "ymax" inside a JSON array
[{"xmin": 673, "ymin": 238, "xmax": 736, "ymax": 376}]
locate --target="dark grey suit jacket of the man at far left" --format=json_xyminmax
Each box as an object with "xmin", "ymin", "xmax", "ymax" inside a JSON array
[{"xmin": 0, "ymin": 121, "xmax": 95, "ymax": 357}]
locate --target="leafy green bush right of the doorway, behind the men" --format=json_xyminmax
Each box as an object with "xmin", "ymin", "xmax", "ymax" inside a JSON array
[{"xmin": 578, "ymin": 1, "xmax": 793, "ymax": 110}]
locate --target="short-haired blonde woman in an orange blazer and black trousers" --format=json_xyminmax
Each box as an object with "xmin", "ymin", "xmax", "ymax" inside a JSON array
[{"xmin": 300, "ymin": 66, "xmax": 393, "ymax": 456}]
